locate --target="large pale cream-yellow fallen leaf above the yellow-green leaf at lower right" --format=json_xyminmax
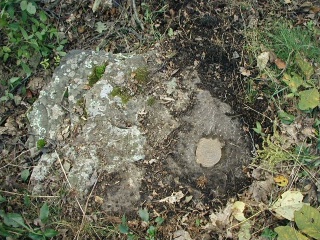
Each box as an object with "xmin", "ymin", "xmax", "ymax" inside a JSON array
[{"xmin": 270, "ymin": 190, "xmax": 305, "ymax": 221}]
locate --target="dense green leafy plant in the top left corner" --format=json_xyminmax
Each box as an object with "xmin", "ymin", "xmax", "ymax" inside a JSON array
[{"xmin": 0, "ymin": 0, "xmax": 67, "ymax": 79}]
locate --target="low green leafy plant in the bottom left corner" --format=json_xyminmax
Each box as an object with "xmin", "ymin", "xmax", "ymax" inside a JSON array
[{"xmin": 0, "ymin": 203, "xmax": 59, "ymax": 240}]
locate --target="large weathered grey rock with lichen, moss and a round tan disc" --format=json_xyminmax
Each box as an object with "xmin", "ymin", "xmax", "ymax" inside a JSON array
[{"xmin": 28, "ymin": 51, "xmax": 249, "ymax": 211}]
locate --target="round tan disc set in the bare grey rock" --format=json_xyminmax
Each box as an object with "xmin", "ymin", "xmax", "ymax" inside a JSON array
[{"xmin": 196, "ymin": 138, "xmax": 223, "ymax": 167}]
